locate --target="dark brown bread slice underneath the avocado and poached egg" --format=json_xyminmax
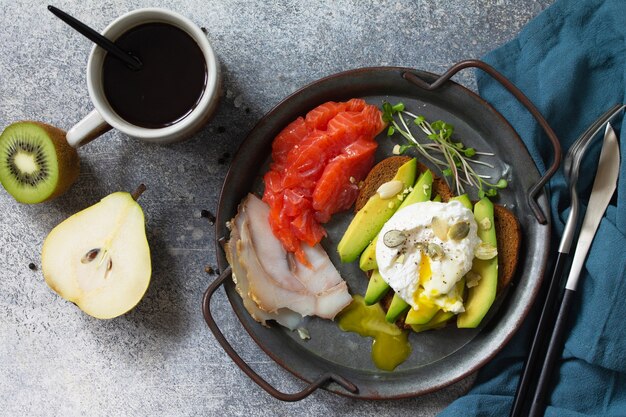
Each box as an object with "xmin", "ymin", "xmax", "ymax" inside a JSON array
[{"xmin": 355, "ymin": 156, "xmax": 522, "ymax": 325}]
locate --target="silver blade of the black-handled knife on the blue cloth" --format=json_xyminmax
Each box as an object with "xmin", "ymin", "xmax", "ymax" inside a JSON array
[{"xmin": 565, "ymin": 123, "xmax": 620, "ymax": 291}]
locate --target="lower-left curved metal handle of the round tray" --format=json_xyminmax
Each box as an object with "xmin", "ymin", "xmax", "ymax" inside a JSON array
[{"xmin": 202, "ymin": 266, "xmax": 359, "ymax": 401}]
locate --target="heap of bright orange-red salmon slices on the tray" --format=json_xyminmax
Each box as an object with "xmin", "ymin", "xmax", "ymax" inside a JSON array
[{"xmin": 263, "ymin": 99, "xmax": 385, "ymax": 266}]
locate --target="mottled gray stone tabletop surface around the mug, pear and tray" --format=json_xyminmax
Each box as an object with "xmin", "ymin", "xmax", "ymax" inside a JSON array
[{"xmin": 0, "ymin": 0, "xmax": 552, "ymax": 416}]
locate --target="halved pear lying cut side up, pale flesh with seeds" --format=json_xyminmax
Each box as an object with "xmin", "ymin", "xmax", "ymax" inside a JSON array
[{"xmin": 41, "ymin": 192, "xmax": 152, "ymax": 319}]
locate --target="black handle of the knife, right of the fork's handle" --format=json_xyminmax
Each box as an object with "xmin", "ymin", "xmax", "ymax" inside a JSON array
[{"xmin": 528, "ymin": 288, "xmax": 576, "ymax": 417}]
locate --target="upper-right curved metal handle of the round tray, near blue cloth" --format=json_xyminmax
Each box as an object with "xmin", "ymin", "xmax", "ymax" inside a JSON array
[{"xmin": 402, "ymin": 59, "xmax": 561, "ymax": 224}]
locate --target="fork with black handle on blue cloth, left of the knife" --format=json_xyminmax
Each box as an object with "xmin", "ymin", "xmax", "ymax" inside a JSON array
[{"xmin": 510, "ymin": 104, "xmax": 626, "ymax": 417}]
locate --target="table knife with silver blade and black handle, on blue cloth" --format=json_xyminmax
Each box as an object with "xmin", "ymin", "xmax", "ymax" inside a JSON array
[{"xmin": 528, "ymin": 123, "xmax": 620, "ymax": 417}]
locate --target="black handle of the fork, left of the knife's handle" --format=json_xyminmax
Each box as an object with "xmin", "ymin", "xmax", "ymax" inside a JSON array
[{"xmin": 510, "ymin": 252, "xmax": 568, "ymax": 417}]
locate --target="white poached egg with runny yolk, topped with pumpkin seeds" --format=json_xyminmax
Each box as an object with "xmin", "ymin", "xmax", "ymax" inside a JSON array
[{"xmin": 376, "ymin": 200, "xmax": 480, "ymax": 313}]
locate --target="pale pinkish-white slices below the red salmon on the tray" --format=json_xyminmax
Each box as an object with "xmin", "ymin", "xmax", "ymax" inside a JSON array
[{"xmin": 226, "ymin": 194, "xmax": 352, "ymax": 328}]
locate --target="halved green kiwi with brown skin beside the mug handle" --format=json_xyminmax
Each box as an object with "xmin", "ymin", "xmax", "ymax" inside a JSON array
[{"xmin": 0, "ymin": 121, "xmax": 80, "ymax": 204}]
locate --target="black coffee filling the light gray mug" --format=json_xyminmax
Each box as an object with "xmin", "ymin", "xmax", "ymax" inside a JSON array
[{"xmin": 102, "ymin": 23, "xmax": 207, "ymax": 129}]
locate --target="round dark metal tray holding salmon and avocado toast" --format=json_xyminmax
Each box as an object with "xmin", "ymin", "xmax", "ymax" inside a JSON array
[{"xmin": 204, "ymin": 67, "xmax": 550, "ymax": 400}]
